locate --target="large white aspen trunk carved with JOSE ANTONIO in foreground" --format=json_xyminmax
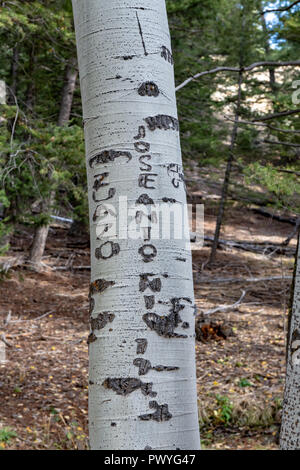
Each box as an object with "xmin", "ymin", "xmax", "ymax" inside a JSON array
[{"xmin": 73, "ymin": 0, "xmax": 200, "ymax": 450}]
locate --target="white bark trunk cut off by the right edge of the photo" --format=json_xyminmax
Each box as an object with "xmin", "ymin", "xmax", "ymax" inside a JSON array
[{"xmin": 280, "ymin": 240, "xmax": 300, "ymax": 450}]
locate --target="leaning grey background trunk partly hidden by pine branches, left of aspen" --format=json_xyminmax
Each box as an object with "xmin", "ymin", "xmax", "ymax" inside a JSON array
[{"xmin": 29, "ymin": 59, "xmax": 78, "ymax": 270}]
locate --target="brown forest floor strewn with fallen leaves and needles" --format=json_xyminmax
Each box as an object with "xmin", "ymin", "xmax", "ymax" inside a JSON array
[{"xmin": 0, "ymin": 167, "xmax": 296, "ymax": 449}]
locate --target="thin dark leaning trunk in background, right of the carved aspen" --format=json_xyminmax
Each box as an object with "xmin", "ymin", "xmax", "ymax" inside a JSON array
[{"xmin": 209, "ymin": 72, "xmax": 243, "ymax": 264}]
